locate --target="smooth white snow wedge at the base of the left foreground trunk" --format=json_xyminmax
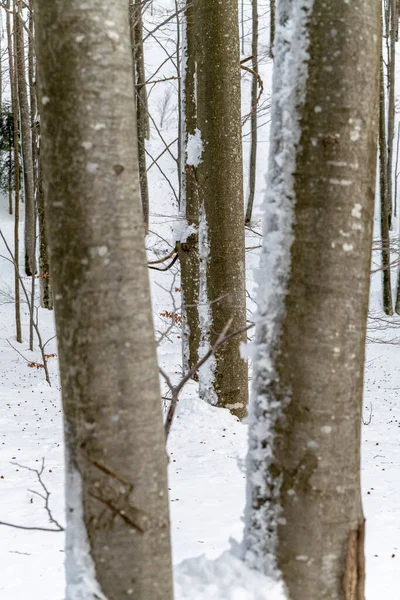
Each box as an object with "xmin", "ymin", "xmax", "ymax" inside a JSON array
[{"xmin": 65, "ymin": 442, "xmax": 107, "ymax": 600}]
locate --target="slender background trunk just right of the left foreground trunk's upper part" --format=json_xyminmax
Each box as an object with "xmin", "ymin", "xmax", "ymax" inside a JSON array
[{"xmin": 129, "ymin": 0, "xmax": 150, "ymax": 231}]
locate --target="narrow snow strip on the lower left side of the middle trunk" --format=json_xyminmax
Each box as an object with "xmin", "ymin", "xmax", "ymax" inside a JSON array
[{"xmin": 198, "ymin": 205, "xmax": 218, "ymax": 405}]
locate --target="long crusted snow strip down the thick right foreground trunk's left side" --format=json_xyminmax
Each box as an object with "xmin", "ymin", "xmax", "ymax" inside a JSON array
[{"xmin": 245, "ymin": 0, "xmax": 314, "ymax": 578}]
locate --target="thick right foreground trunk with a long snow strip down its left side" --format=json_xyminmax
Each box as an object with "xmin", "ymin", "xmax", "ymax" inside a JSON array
[{"xmin": 246, "ymin": 0, "xmax": 381, "ymax": 600}]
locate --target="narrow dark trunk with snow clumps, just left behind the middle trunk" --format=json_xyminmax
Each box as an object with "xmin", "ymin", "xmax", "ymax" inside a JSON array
[{"xmin": 178, "ymin": 0, "xmax": 200, "ymax": 371}]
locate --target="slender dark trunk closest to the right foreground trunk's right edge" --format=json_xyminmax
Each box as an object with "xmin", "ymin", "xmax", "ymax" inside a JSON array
[{"xmin": 379, "ymin": 51, "xmax": 393, "ymax": 315}]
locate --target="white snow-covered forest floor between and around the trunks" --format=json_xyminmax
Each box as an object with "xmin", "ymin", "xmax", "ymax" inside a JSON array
[{"xmin": 0, "ymin": 199, "xmax": 400, "ymax": 600}]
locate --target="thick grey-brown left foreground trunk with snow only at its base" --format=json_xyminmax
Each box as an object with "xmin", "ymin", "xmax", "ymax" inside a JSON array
[{"xmin": 36, "ymin": 0, "xmax": 173, "ymax": 600}]
